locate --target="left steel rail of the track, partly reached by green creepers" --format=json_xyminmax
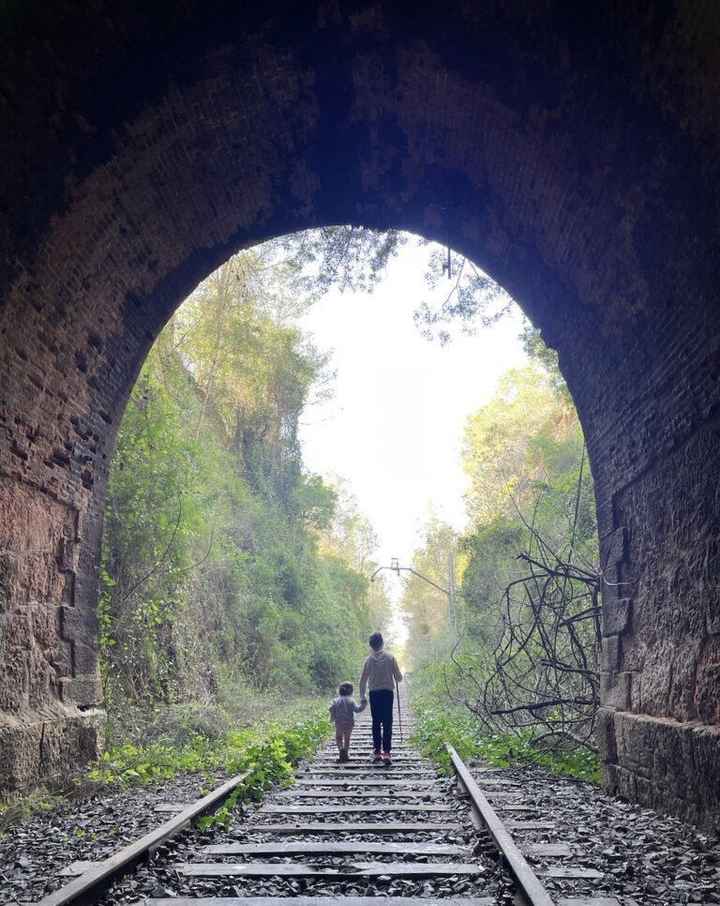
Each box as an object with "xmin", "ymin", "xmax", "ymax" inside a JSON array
[{"xmin": 37, "ymin": 771, "xmax": 250, "ymax": 906}]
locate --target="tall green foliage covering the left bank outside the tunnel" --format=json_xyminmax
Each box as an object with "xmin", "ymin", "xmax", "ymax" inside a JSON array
[{"xmin": 99, "ymin": 234, "xmax": 390, "ymax": 708}]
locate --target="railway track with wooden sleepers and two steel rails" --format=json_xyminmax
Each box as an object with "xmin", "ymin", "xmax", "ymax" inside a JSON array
[{"xmin": 41, "ymin": 715, "xmax": 619, "ymax": 906}]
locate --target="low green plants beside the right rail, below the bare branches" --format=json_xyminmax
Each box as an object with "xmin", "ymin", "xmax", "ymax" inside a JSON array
[{"xmin": 414, "ymin": 704, "xmax": 601, "ymax": 783}]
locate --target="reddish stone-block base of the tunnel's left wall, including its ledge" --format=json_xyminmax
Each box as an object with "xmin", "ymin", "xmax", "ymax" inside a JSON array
[{"xmin": 0, "ymin": 476, "xmax": 102, "ymax": 789}]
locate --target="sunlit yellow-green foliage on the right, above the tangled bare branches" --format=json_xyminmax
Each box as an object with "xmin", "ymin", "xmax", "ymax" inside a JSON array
[{"xmin": 403, "ymin": 363, "xmax": 597, "ymax": 678}]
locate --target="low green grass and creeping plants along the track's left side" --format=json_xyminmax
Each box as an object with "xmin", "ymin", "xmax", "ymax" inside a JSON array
[{"xmin": 0, "ymin": 687, "xmax": 331, "ymax": 834}]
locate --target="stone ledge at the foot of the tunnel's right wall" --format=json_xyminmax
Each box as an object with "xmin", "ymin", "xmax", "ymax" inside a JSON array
[{"xmin": 599, "ymin": 708, "xmax": 720, "ymax": 830}]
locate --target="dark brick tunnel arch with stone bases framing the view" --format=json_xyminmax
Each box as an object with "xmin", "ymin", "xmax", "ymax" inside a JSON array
[{"xmin": 0, "ymin": 0, "xmax": 720, "ymax": 821}]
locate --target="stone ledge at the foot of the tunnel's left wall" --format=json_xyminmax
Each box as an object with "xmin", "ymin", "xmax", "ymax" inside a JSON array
[{"xmin": 0, "ymin": 709, "xmax": 105, "ymax": 790}]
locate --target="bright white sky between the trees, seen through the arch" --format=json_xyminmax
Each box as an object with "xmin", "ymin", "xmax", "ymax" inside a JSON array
[{"xmin": 299, "ymin": 241, "xmax": 526, "ymax": 591}]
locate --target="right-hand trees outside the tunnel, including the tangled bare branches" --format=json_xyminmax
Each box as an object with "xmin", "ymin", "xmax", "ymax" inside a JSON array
[{"xmin": 407, "ymin": 354, "xmax": 600, "ymax": 744}]
